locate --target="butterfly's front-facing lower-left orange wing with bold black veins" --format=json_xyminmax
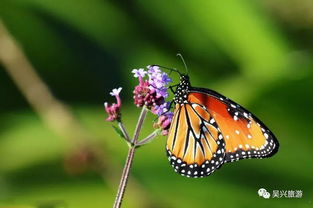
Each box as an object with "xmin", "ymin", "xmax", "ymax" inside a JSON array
[{"xmin": 166, "ymin": 103, "xmax": 225, "ymax": 178}]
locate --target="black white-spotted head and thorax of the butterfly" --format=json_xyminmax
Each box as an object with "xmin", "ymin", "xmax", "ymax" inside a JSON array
[{"xmin": 174, "ymin": 74, "xmax": 190, "ymax": 104}]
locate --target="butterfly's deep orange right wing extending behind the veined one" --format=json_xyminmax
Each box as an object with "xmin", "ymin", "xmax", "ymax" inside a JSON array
[{"xmin": 188, "ymin": 88, "xmax": 279, "ymax": 162}]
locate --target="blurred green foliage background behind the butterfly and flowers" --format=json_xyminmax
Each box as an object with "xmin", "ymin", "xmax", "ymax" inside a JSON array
[{"xmin": 0, "ymin": 0, "xmax": 313, "ymax": 208}]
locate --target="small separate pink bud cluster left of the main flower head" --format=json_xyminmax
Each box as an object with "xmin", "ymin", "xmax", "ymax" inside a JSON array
[{"xmin": 104, "ymin": 87, "xmax": 122, "ymax": 121}]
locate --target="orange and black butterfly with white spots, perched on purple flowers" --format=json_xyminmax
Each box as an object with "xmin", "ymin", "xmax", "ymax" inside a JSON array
[{"xmin": 166, "ymin": 68, "xmax": 279, "ymax": 178}]
